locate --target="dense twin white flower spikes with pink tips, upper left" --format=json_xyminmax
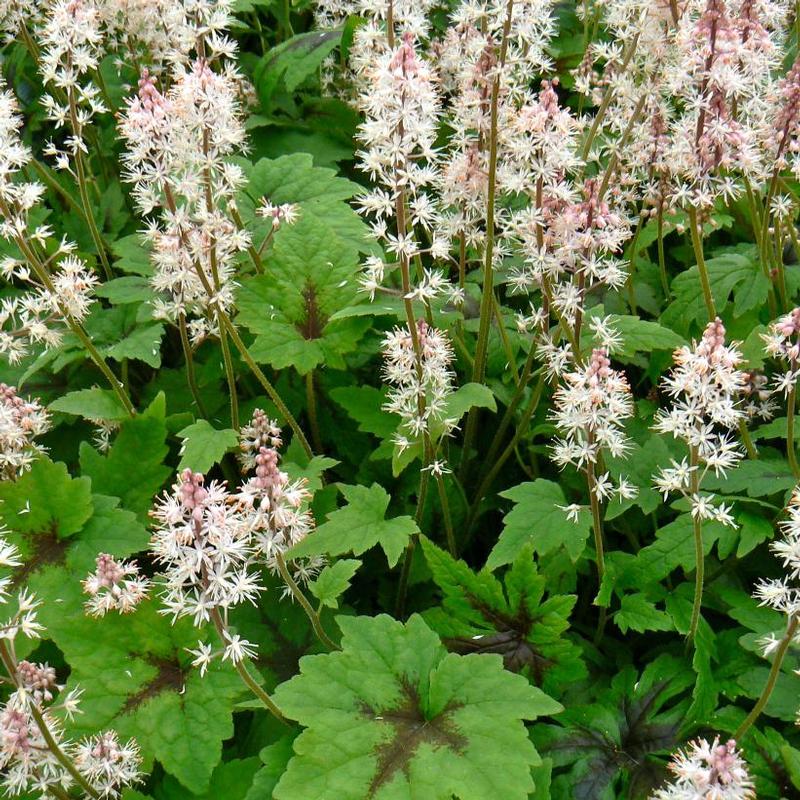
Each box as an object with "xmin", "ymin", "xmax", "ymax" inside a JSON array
[{"xmin": 120, "ymin": 58, "xmax": 250, "ymax": 341}]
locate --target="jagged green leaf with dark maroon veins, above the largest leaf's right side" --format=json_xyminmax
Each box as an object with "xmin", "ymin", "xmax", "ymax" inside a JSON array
[{"xmin": 421, "ymin": 537, "xmax": 586, "ymax": 694}]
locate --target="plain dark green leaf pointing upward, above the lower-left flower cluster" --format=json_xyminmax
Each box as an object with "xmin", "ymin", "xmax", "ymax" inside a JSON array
[{"xmin": 80, "ymin": 394, "xmax": 172, "ymax": 519}]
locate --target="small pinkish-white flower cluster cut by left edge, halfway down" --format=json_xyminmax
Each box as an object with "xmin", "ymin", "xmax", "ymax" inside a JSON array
[{"xmin": 0, "ymin": 383, "xmax": 50, "ymax": 480}]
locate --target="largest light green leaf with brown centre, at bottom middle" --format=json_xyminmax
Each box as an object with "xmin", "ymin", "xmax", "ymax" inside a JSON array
[{"xmin": 273, "ymin": 615, "xmax": 561, "ymax": 800}]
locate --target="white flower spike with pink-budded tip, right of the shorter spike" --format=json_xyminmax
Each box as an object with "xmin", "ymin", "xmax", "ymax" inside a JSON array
[{"xmin": 653, "ymin": 319, "xmax": 746, "ymax": 525}]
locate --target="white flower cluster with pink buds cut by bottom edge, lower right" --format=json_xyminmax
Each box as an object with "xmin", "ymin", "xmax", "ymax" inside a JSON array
[{"xmin": 652, "ymin": 739, "xmax": 756, "ymax": 800}]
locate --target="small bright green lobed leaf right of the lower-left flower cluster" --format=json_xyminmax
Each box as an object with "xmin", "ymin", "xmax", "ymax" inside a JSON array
[{"xmin": 289, "ymin": 483, "xmax": 419, "ymax": 567}]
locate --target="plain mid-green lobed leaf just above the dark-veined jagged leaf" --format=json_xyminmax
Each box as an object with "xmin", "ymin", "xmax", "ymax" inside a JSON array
[{"xmin": 486, "ymin": 478, "xmax": 592, "ymax": 570}]
